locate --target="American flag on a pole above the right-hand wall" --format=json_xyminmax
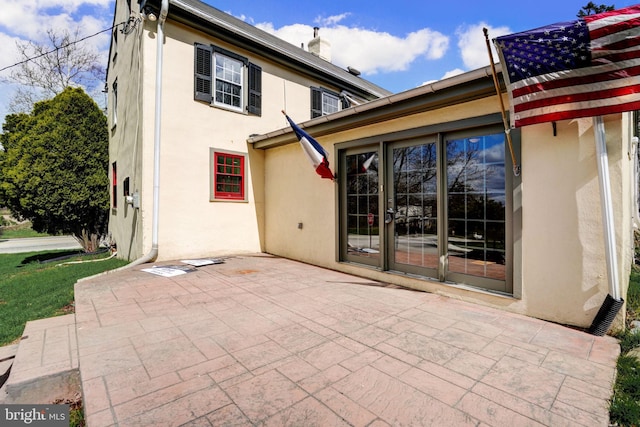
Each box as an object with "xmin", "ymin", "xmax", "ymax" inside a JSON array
[{"xmin": 494, "ymin": 5, "xmax": 640, "ymax": 127}]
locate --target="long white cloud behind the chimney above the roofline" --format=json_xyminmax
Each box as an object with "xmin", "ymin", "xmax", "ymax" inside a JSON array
[{"xmin": 256, "ymin": 21, "xmax": 449, "ymax": 75}]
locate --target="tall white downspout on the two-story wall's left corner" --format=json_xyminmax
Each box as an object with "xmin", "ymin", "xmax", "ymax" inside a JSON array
[{"xmin": 127, "ymin": 0, "xmax": 169, "ymax": 267}]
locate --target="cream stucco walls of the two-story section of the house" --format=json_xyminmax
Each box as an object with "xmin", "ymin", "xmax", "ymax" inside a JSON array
[{"xmin": 110, "ymin": 2, "xmax": 350, "ymax": 260}]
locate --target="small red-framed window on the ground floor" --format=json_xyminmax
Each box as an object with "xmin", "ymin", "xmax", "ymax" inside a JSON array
[{"xmin": 211, "ymin": 149, "xmax": 247, "ymax": 201}]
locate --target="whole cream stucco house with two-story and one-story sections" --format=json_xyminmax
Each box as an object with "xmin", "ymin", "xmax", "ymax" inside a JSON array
[{"xmin": 108, "ymin": 0, "xmax": 638, "ymax": 327}]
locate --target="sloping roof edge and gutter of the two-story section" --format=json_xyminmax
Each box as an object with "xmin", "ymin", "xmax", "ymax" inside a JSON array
[{"xmin": 146, "ymin": 0, "xmax": 392, "ymax": 100}]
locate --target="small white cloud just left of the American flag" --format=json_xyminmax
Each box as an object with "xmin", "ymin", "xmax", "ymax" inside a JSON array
[{"xmin": 456, "ymin": 22, "xmax": 512, "ymax": 70}]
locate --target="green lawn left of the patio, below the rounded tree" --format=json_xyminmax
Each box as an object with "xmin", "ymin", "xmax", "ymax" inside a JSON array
[{"xmin": 0, "ymin": 251, "xmax": 126, "ymax": 346}]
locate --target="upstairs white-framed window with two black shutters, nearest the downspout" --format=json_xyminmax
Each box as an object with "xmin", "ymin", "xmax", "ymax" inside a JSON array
[{"xmin": 194, "ymin": 43, "xmax": 262, "ymax": 116}]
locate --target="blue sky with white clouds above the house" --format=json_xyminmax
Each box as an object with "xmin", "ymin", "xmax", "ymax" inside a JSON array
[{"xmin": 0, "ymin": 0, "xmax": 638, "ymax": 127}]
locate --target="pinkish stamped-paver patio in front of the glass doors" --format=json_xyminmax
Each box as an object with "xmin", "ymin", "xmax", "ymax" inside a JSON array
[{"xmin": 76, "ymin": 255, "xmax": 619, "ymax": 427}]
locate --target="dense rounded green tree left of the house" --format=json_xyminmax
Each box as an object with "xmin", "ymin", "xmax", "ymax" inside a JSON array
[{"xmin": 0, "ymin": 87, "xmax": 109, "ymax": 252}]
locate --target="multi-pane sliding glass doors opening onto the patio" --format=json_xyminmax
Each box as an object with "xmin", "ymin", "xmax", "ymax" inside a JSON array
[{"xmin": 339, "ymin": 122, "xmax": 513, "ymax": 293}]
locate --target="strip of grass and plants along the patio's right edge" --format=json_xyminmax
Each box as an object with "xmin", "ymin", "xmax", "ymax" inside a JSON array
[{"xmin": 609, "ymin": 266, "xmax": 640, "ymax": 427}]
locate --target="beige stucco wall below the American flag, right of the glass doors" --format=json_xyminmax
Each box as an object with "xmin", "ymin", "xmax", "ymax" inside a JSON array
[{"xmin": 522, "ymin": 115, "xmax": 634, "ymax": 326}]
